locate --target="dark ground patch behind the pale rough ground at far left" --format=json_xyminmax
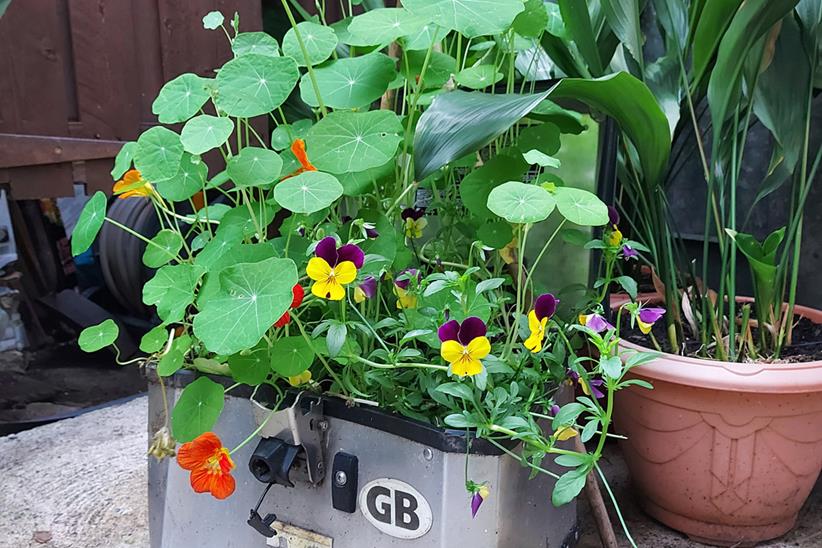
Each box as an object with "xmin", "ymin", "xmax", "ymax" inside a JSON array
[{"xmin": 0, "ymin": 343, "xmax": 146, "ymax": 435}]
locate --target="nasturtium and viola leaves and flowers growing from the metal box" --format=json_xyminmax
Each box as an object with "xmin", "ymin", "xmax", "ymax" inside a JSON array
[{"xmin": 72, "ymin": 0, "xmax": 664, "ymax": 544}]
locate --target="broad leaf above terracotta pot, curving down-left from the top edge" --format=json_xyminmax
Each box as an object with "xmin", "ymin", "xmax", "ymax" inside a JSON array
[{"xmin": 708, "ymin": 0, "xmax": 798, "ymax": 133}]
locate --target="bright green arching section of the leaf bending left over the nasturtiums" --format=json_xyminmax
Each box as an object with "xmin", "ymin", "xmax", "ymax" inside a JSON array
[{"xmin": 550, "ymin": 72, "xmax": 671, "ymax": 184}]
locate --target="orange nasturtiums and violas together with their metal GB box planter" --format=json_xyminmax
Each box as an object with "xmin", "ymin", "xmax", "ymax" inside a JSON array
[{"xmin": 72, "ymin": 4, "xmax": 664, "ymax": 546}]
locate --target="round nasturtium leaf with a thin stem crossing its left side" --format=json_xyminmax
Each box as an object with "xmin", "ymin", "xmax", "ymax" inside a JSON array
[{"xmin": 300, "ymin": 53, "xmax": 397, "ymax": 109}]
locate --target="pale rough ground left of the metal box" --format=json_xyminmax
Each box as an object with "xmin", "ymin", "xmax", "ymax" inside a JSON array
[{"xmin": 0, "ymin": 397, "xmax": 148, "ymax": 548}]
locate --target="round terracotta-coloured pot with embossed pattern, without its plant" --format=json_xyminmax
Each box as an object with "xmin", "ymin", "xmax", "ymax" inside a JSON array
[{"xmin": 614, "ymin": 306, "xmax": 822, "ymax": 546}]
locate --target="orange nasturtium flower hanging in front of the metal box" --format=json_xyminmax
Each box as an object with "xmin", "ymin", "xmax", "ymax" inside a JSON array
[{"xmin": 177, "ymin": 432, "xmax": 235, "ymax": 499}]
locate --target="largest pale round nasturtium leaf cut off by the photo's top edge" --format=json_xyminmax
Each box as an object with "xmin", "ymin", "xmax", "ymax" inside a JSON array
[{"xmin": 403, "ymin": 0, "xmax": 525, "ymax": 38}]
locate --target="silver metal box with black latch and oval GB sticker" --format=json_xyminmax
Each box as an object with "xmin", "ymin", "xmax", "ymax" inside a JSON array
[{"xmin": 149, "ymin": 374, "xmax": 577, "ymax": 548}]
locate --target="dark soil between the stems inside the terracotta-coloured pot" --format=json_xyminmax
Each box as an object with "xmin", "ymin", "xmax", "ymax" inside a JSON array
[{"xmin": 624, "ymin": 318, "xmax": 822, "ymax": 363}]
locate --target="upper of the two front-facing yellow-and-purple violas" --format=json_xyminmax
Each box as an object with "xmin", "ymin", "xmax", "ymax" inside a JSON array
[{"xmin": 305, "ymin": 236, "xmax": 365, "ymax": 301}]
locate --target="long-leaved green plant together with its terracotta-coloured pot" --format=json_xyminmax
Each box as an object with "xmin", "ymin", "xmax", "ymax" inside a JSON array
[{"xmin": 549, "ymin": 1, "xmax": 822, "ymax": 545}]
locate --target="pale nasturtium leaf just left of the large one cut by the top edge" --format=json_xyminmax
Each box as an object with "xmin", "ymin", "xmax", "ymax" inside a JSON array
[{"xmin": 346, "ymin": 8, "xmax": 429, "ymax": 46}]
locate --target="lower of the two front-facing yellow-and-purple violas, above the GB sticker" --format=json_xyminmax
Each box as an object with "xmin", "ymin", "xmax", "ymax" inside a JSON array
[{"xmin": 437, "ymin": 316, "xmax": 491, "ymax": 377}]
